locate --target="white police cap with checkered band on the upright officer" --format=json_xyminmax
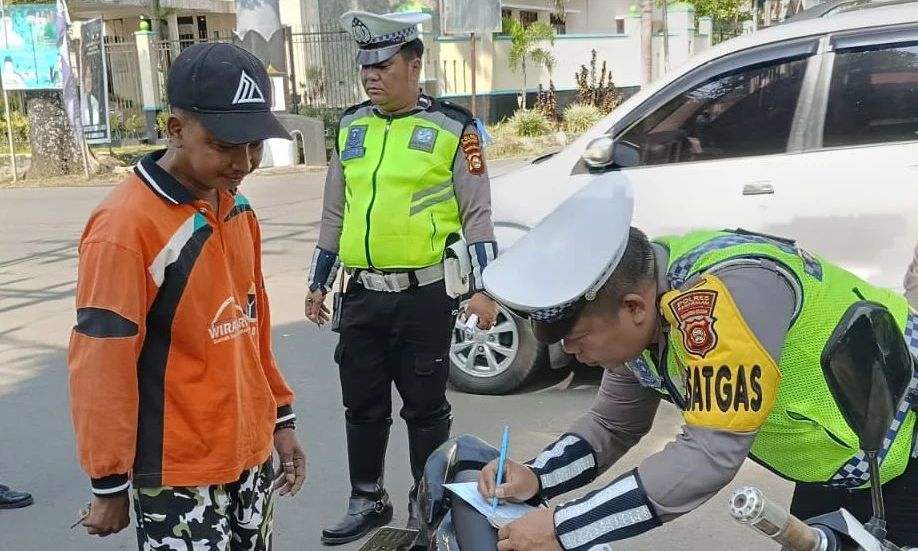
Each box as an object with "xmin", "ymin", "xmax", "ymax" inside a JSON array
[{"xmin": 339, "ymin": 11, "xmax": 430, "ymax": 65}]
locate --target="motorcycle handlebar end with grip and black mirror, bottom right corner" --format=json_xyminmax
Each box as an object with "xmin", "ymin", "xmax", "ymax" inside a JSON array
[{"xmin": 729, "ymin": 301, "xmax": 918, "ymax": 551}]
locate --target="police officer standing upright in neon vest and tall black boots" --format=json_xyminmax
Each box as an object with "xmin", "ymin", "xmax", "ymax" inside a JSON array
[{"xmin": 306, "ymin": 11, "xmax": 497, "ymax": 544}]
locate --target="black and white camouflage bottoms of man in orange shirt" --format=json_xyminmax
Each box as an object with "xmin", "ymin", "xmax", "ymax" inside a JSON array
[{"xmin": 133, "ymin": 459, "xmax": 274, "ymax": 551}]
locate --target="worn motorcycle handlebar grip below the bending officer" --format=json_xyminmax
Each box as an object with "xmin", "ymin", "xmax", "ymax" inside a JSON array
[{"xmin": 730, "ymin": 486, "xmax": 828, "ymax": 551}]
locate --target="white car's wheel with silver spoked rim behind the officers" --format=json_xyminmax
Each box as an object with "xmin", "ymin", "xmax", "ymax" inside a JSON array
[{"xmin": 449, "ymin": 302, "xmax": 546, "ymax": 394}]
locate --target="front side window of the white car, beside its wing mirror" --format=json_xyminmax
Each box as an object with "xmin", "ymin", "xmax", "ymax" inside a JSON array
[{"xmin": 616, "ymin": 58, "xmax": 807, "ymax": 165}]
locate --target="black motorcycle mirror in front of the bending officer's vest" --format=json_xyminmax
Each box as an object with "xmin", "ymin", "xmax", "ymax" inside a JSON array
[{"xmin": 821, "ymin": 301, "xmax": 913, "ymax": 452}]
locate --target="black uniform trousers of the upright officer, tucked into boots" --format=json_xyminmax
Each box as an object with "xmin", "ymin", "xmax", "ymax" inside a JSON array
[{"xmin": 335, "ymin": 279, "xmax": 457, "ymax": 429}]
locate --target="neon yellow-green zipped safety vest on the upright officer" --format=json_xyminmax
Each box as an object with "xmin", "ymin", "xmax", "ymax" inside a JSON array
[{"xmin": 337, "ymin": 97, "xmax": 473, "ymax": 270}]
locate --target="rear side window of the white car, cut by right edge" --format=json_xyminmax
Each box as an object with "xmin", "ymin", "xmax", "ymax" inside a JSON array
[{"xmin": 823, "ymin": 44, "xmax": 918, "ymax": 147}]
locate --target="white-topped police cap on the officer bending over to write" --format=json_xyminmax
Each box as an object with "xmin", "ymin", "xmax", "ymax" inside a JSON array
[{"xmin": 482, "ymin": 179, "xmax": 634, "ymax": 343}]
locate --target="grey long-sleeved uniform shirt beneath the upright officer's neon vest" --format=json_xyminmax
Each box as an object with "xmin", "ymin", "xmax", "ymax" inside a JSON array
[{"xmin": 317, "ymin": 94, "xmax": 495, "ymax": 280}]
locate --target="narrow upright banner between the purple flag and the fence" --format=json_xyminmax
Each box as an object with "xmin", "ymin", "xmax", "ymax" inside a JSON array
[{"xmin": 80, "ymin": 18, "xmax": 111, "ymax": 144}]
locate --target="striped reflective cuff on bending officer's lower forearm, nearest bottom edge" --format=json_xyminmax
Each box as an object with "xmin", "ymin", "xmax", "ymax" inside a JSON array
[{"xmin": 554, "ymin": 469, "xmax": 662, "ymax": 551}]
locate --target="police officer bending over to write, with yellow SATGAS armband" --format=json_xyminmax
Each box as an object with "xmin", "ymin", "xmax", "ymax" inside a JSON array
[{"xmin": 479, "ymin": 179, "xmax": 918, "ymax": 551}]
